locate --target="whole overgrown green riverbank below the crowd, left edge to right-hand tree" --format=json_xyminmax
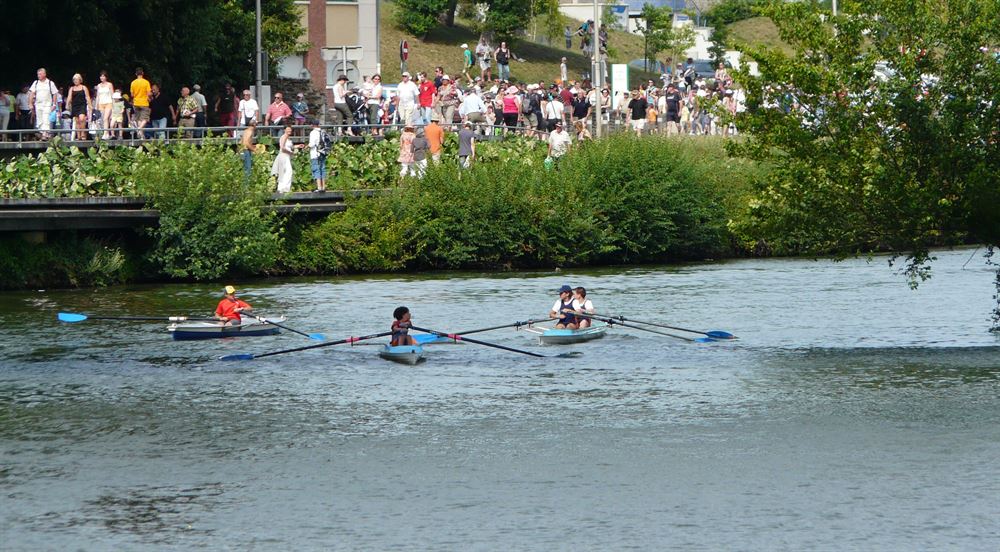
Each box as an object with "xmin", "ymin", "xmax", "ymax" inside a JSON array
[{"xmin": 0, "ymin": 134, "xmax": 764, "ymax": 289}]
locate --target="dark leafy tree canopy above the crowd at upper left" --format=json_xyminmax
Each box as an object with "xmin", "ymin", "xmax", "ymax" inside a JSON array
[{"xmin": 0, "ymin": 0, "xmax": 303, "ymax": 94}]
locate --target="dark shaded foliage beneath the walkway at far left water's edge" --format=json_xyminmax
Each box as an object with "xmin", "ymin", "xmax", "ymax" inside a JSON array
[{"xmin": 0, "ymin": 232, "xmax": 136, "ymax": 289}]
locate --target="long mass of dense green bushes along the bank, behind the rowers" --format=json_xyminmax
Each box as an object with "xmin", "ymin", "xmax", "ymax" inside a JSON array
[{"xmin": 284, "ymin": 134, "xmax": 760, "ymax": 273}]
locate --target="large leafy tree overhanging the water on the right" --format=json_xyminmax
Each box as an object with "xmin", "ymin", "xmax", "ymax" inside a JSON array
[{"xmin": 730, "ymin": 0, "xmax": 1000, "ymax": 324}]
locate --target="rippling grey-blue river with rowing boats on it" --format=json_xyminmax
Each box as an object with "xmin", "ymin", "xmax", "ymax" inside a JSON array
[{"xmin": 0, "ymin": 250, "xmax": 1000, "ymax": 550}]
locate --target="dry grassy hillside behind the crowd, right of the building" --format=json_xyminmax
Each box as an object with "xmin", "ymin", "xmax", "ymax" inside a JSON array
[{"xmin": 380, "ymin": 2, "xmax": 660, "ymax": 84}]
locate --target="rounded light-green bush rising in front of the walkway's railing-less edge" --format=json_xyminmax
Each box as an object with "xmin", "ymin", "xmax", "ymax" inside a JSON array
[{"xmin": 136, "ymin": 140, "xmax": 282, "ymax": 280}]
